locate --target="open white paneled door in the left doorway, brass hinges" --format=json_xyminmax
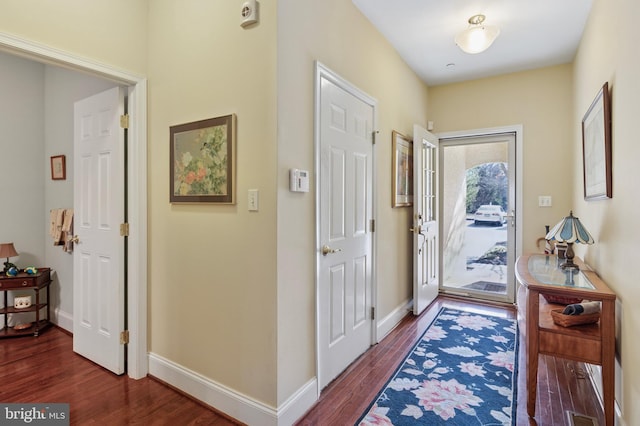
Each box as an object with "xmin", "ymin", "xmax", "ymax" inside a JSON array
[{"xmin": 73, "ymin": 87, "xmax": 125, "ymax": 374}]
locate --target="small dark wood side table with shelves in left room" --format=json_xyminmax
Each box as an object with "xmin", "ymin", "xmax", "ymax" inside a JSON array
[{"xmin": 0, "ymin": 268, "xmax": 51, "ymax": 339}]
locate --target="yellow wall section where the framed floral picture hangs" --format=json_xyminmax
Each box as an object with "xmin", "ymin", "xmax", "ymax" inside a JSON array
[{"xmin": 148, "ymin": 0, "xmax": 277, "ymax": 406}]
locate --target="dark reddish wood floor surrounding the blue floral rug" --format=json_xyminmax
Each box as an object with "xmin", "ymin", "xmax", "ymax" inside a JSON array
[{"xmin": 0, "ymin": 298, "xmax": 604, "ymax": 426}]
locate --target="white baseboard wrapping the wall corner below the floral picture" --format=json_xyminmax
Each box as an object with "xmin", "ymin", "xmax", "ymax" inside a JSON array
[{"xmin": 149, "ymin": 353, "xmax": 317, "ymax": 426}]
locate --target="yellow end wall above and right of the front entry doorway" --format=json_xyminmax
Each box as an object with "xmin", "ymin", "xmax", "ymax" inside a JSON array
[{"xmin": 429, "ymin": 65, "xmax": 579, "ymax": 252}]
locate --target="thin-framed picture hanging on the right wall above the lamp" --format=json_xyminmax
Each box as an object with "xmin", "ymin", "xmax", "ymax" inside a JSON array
[{"xmin": 582, "ymin": 82, "xmax": 613, "ymax": 200}]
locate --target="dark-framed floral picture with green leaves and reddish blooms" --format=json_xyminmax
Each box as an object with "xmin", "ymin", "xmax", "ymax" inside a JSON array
[{"xmin": 169, "ymin": 114, "xmax": 236, "ymax": 204}]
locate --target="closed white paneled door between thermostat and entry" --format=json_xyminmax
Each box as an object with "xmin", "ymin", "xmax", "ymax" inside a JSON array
[{"xmin": 318, "ymin": 65, "xmax": 374, "ymax": 389}]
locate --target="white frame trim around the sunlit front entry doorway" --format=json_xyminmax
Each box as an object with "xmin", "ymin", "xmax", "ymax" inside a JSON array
[{"xmin": 436, "ymin": 124, "xmax": 524, "ymax": 303}]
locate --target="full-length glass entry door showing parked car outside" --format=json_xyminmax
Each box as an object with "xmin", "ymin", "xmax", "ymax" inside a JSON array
[{"xmin": 440, "ymin": 133, "xmax": 516, "ymax": 302}]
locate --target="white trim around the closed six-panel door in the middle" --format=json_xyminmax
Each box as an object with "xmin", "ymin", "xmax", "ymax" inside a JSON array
[{"xmin": 313, "ymin": 61, "xmax": 379, "ymax": 398}]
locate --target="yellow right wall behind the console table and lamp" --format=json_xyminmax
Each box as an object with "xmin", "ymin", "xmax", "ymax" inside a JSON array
[{"xmin": 571, "ymin": 0, "xmax": 640, "ymax": 425}]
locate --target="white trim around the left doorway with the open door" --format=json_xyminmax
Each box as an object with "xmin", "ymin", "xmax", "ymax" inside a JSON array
[{"xmin": 0, "ymin": 33, "xmax": 148, "ymax": 379}]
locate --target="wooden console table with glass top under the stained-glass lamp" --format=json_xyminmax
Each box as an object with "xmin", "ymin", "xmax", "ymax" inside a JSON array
[{"xmin": 516, "ymin": 254, "xmax": 616, "ymax": 426}]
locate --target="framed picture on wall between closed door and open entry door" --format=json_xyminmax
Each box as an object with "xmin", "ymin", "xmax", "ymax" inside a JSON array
[{"xmin": 391, "ymin": 130, "xmax": 413, "ymax": 207}]
